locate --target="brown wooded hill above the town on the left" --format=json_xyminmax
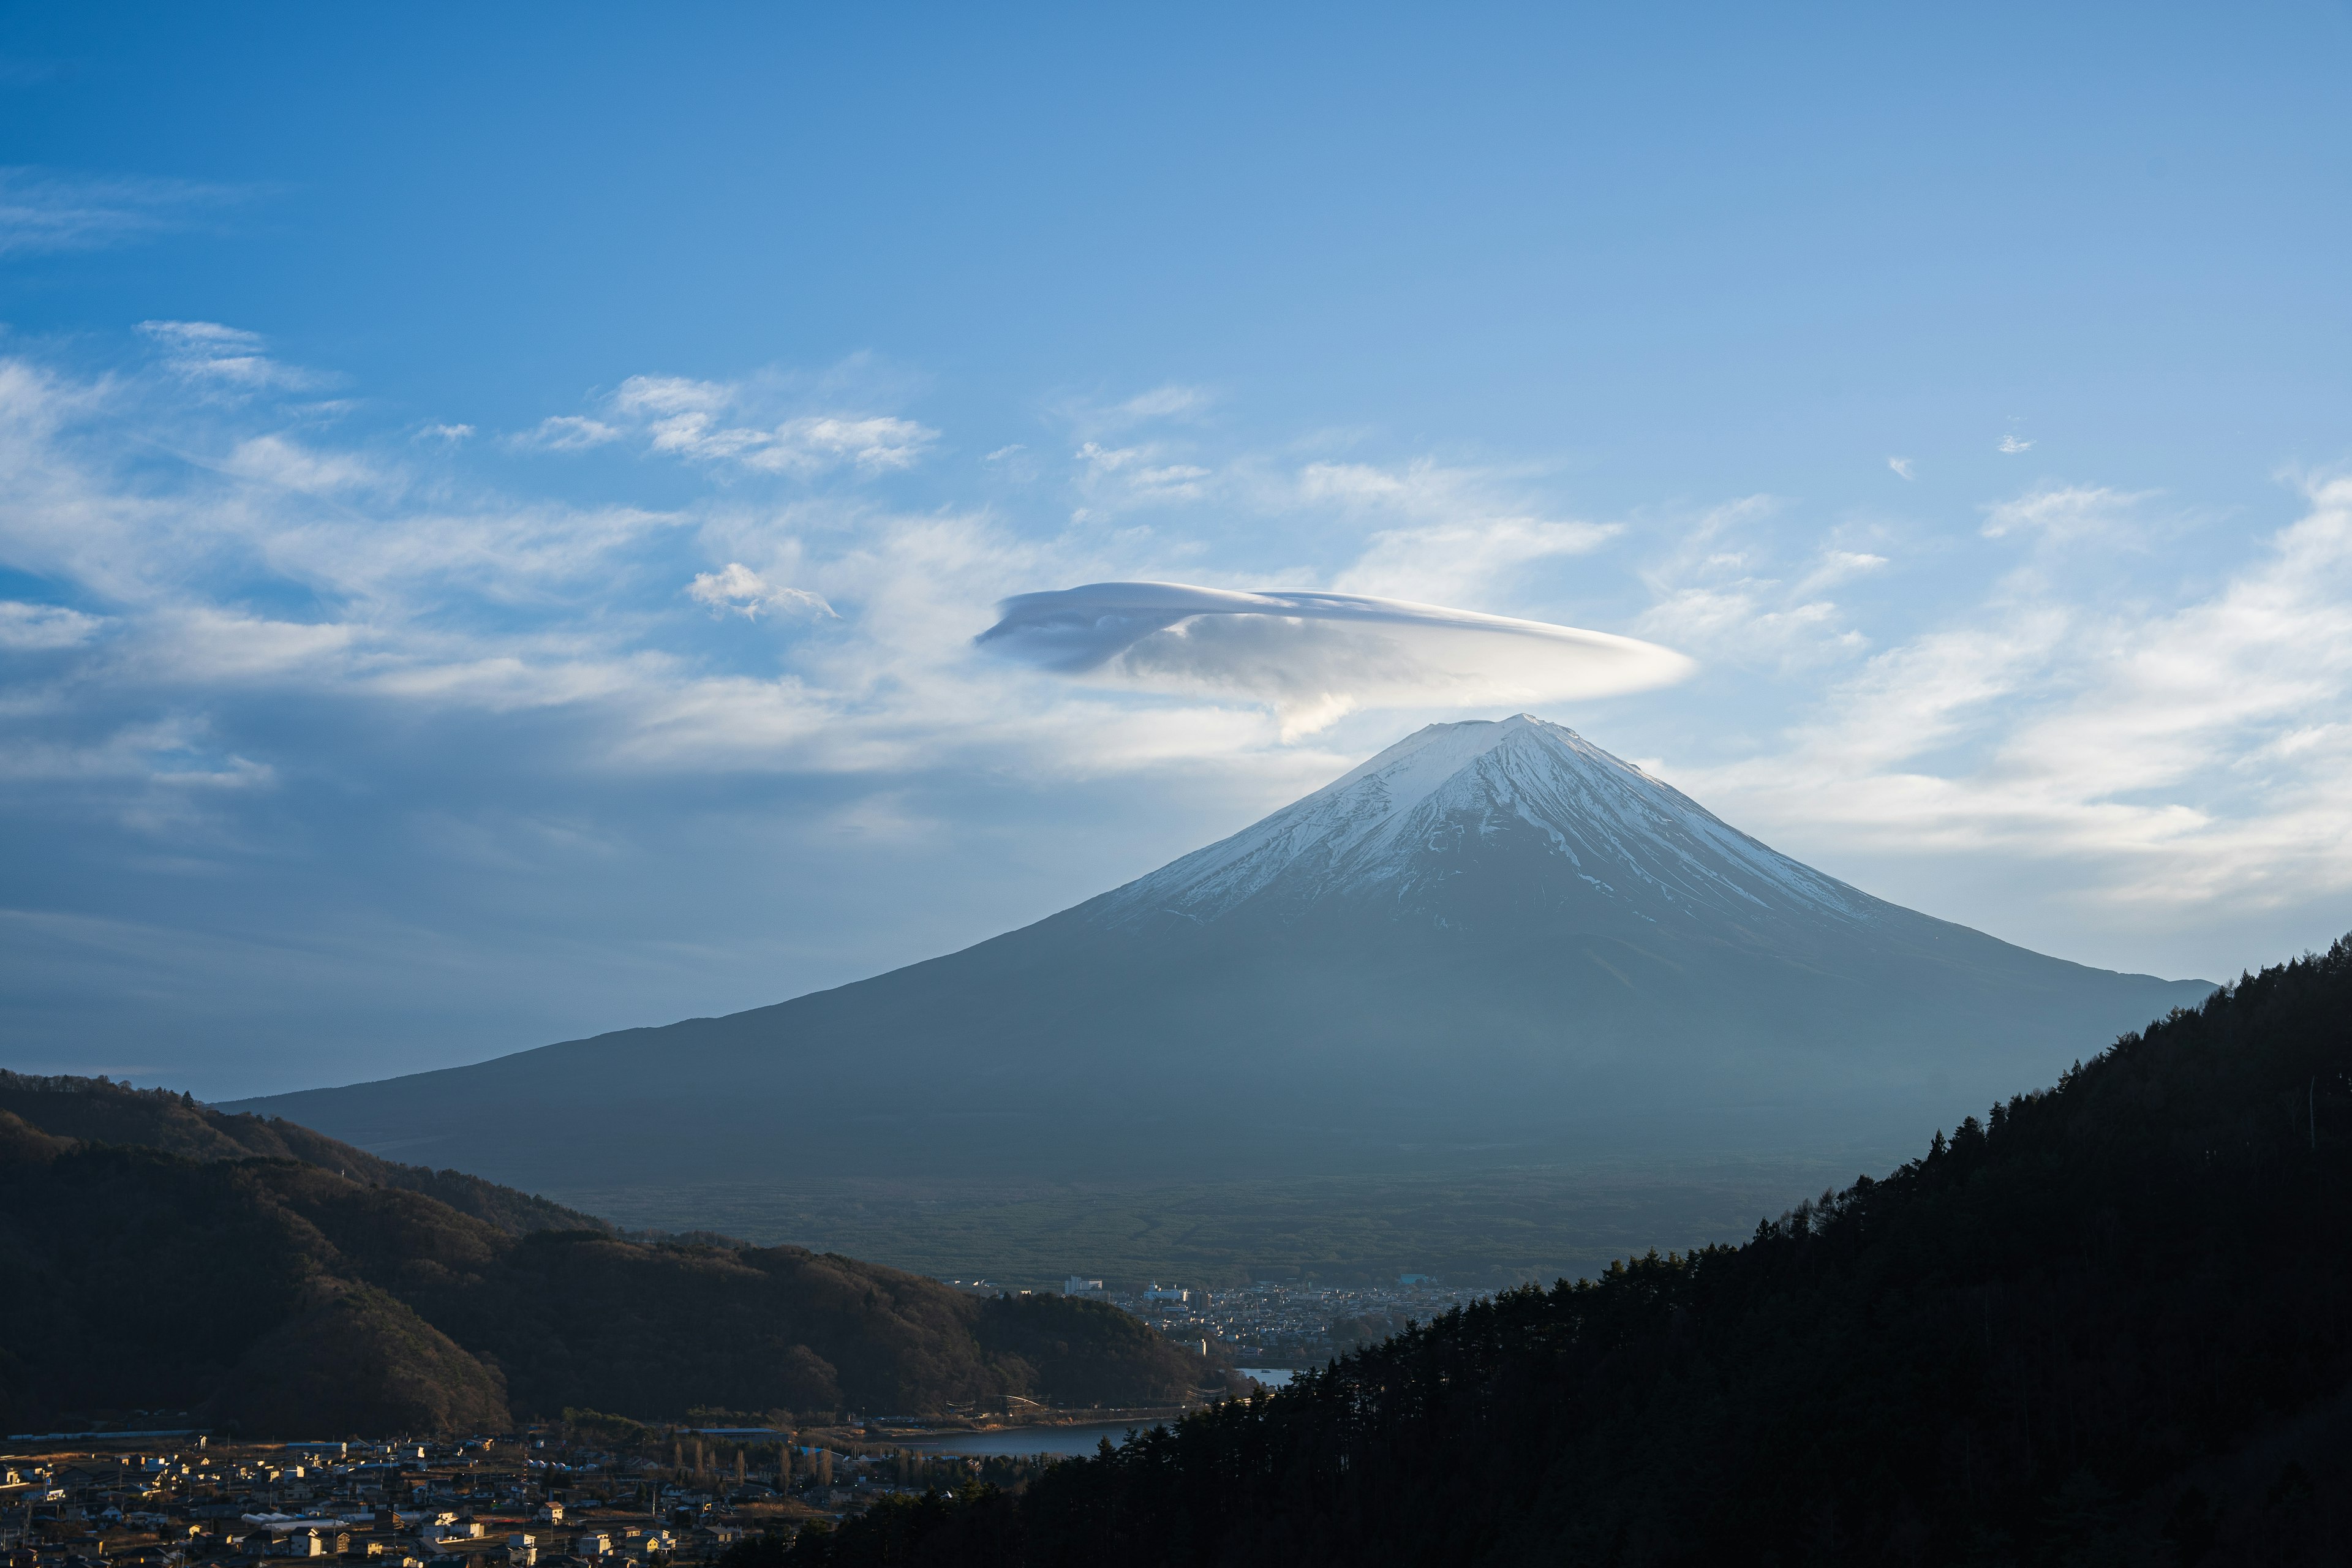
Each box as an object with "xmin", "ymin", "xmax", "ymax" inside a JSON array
[{"xmin": 0, "ymin": 1074, "xmax": 1218, "ymax": 1436}]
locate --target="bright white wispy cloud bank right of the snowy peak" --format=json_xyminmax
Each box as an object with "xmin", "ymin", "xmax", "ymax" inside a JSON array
[{"xmin": 1677, "ymin": 477, "xmax": 2352, "ymax": 940}]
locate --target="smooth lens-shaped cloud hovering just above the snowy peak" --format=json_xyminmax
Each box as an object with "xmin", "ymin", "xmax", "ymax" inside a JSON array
[{"xmin": 974, "ymin": 583, "xmax": 1691, "ymax": 733}]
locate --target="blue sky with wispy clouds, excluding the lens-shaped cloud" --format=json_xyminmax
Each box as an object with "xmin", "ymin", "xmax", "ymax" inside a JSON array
[{"xmin": 0, "ymin": 5, "xmax": 2352, "ymax": 1096}]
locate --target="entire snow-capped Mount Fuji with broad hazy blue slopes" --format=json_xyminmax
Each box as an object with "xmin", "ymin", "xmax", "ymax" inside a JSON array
[{"xmin": 233, "ymin": 715, "xmax": 2211, "ymax": 1192}]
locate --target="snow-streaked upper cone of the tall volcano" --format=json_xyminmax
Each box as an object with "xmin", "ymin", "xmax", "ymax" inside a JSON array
[{"xmin": 1087, "ymin": 712, "xmax": 1882, "ymax": 926}]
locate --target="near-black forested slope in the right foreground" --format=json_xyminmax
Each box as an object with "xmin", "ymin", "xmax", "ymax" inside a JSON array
[{"xmin": 790, "ymin": 938, "xmax": 2352, "ymax": 1568}]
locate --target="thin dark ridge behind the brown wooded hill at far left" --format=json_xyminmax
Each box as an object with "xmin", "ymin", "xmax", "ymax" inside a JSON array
[{"xmin": 0, "ymin": 1069, "xmax": 611, "ymax": 1237}]
